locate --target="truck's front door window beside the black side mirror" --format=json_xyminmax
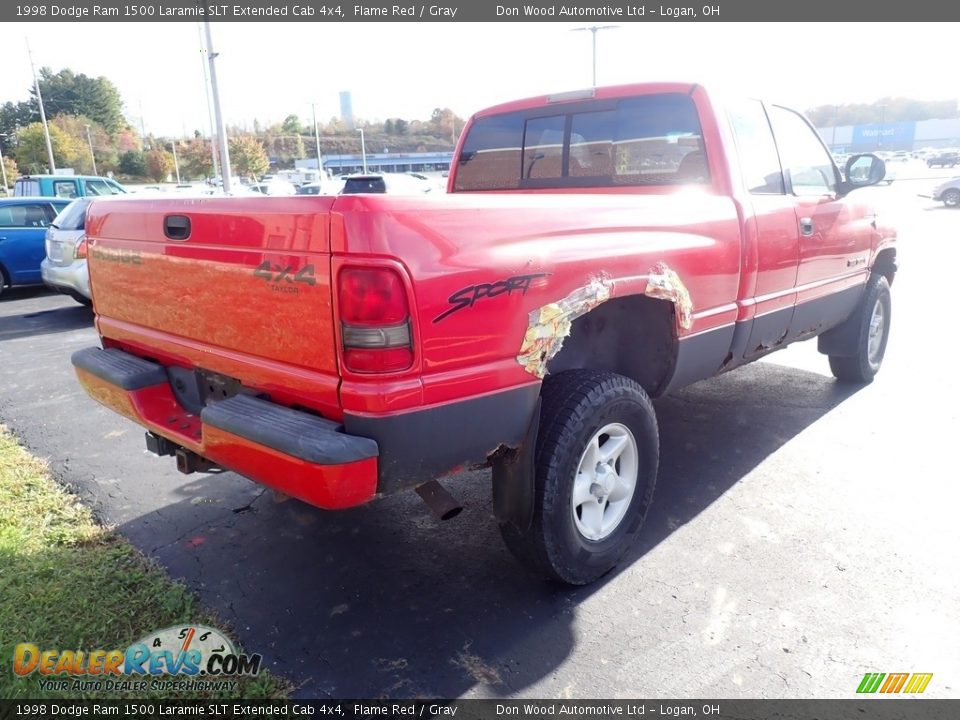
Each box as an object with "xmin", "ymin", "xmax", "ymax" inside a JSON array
[{"xmin": 770, "ymin": 106, "xmax": 837, "ymax": 196}]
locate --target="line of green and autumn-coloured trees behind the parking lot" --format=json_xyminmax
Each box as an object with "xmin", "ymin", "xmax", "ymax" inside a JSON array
[{"xmin": 0, "ymin": 67, "xmax": 463, "ymax": 187}]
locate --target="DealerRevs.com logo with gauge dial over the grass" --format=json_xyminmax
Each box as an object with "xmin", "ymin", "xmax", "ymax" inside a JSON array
[{"xmin": 13, "ymin": 625, "xmax": 262, "ymax": 692}]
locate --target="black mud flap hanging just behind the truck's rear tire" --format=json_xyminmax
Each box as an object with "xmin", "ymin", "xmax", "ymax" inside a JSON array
[{"xmin": 493, "ymin": 397, "xmax": 541, "ymax": 533}]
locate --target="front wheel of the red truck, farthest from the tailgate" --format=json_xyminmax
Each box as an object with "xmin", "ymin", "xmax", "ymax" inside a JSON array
[{"xmin": 829, "ymin": 274, "xmax": 892, "ymax": 384}]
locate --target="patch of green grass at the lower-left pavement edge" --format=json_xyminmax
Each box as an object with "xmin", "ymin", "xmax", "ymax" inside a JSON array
[{"xmin": 0, "ymin": 425, "xmax": 288, "ymax": 699}]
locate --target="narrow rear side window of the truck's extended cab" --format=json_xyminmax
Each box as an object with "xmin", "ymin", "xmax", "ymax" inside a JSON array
[{"xmin": 730, "ymin": 100, "xmax": 784, "ymax": 195}]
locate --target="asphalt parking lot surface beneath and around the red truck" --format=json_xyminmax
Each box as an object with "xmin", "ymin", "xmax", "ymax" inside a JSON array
[{"xmin": 0, "ymin": 171, "xmax": 960, "ymax": 698}]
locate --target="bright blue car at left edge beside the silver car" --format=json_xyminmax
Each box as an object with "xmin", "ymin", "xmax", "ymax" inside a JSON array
[{"xmin": 0, "ymin": 197, "xmax": 70, "ymax": 295}]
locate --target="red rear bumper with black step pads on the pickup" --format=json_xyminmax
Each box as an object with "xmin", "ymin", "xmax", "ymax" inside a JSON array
[{"xmin": 72, "ymin": 348, "xmax": 379, "ymax": 509}]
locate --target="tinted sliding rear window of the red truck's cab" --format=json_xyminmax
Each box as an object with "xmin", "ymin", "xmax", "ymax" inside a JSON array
[{"xmin": 454, "ymin": 93, "xmax": 710, "ymax": 191}]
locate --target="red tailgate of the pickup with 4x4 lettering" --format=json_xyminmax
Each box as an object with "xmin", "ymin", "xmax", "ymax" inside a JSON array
[{"xmin": 87, "ymin": 196, "xmax": 336, "ymax": 375}]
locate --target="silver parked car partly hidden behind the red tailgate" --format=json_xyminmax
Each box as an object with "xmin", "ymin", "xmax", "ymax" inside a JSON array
[{"xmin": 40, "ymin": 197, "xmax": 93, "ymax": 305}]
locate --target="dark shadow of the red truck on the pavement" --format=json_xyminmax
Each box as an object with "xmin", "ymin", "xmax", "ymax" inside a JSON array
[{"xmin": 119, "ymin": 363, "xmax": 856, "ymax": 698}]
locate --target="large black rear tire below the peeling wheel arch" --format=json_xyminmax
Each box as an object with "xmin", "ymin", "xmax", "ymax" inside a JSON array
[{"xmin": 500, "ymin": 370, "xmax": 660, "ymax": 585}]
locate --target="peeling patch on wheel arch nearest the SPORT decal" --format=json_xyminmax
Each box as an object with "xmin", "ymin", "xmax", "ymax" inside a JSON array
[{"xmin": 517, "ymin": 278, "xmax": 612, "ymax": 378}]
